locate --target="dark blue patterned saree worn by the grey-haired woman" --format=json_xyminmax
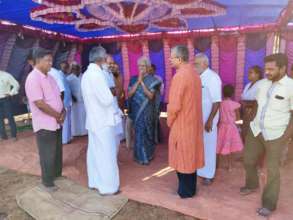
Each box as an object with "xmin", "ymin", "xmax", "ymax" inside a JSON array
[{"xmin": 128, "ymin": 75, "xmax": 161, "ymax": 164}]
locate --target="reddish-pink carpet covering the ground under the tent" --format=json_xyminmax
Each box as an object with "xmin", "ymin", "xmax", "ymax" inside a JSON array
[{"xmin": 0, "ymin": 119, "xmax": 293, "ymax": 220}]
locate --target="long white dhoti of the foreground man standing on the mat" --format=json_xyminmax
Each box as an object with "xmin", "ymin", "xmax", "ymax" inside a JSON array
[{"xmin": 87, "ymin": 127, "xmax": 120, "ymax": 194}]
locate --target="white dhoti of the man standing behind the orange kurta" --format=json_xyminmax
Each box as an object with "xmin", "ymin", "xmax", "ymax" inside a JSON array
[{"xmin": 197, "ymin": 126, "xmax": 218, "ymax": 179}]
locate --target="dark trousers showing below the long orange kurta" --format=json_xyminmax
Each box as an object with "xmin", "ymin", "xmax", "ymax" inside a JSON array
[{"xmin": 177, "ymin": 171, "xmax": 197, "ymax": 198}]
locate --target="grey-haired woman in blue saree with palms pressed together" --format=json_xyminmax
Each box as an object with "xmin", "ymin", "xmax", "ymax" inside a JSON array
[{"xmin": 128, "ymin": 57, "xmax": 161, "ymax": 165}]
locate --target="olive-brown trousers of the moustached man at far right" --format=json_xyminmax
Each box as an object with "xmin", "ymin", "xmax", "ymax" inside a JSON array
[{"xmin": 244, "ymin": 130, "xmax": 285, "ymax": 210}]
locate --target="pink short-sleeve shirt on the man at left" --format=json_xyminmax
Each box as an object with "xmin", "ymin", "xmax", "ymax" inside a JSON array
[{"xmin": 25, "ymin": 68, "xmax": 63, "ymax": 132}]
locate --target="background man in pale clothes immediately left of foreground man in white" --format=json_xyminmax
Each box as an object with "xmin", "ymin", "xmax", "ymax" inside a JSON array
[{"xmin": 67, "ymin": 64, "xmax": 87, "ymax": 136}]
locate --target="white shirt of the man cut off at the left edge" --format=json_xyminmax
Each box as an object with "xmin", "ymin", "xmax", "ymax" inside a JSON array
[{"xmin": 0, "ymin": 71, "xmax": 19, "ymax": 99}]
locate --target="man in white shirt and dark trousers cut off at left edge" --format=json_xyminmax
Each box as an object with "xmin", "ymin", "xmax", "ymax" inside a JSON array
[{"xmin": 0, "ymin": 71, "xmax": 19, "ymax": 140}]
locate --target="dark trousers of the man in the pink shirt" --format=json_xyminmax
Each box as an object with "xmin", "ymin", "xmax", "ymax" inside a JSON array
[{"xmin": 36, "ymin": 129, "xmax": 63, "ymax": 187}]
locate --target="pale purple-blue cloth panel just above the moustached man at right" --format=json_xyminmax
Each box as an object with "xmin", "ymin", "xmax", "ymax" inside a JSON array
[{"xmin": 243, "ymin": 34, "xmax": 267, "ymax": 85}]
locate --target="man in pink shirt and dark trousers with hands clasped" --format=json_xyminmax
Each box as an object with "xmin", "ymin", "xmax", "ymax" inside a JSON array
[{"xmin": 25, "ymin": 49, "xmax": 65, "ymax": 191}]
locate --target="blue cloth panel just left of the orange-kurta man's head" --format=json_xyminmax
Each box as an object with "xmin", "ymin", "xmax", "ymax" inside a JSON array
[{"xmin": 148, "ymin": 40, "xmax": 166, "ymax": 100}]
